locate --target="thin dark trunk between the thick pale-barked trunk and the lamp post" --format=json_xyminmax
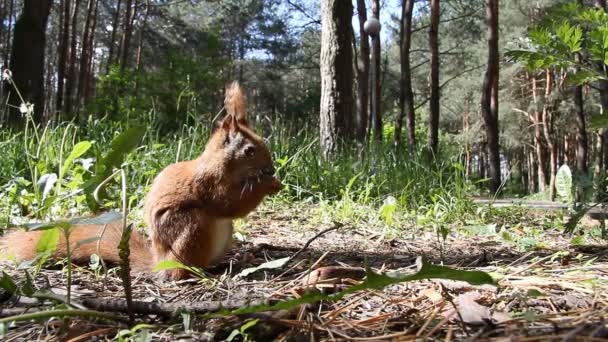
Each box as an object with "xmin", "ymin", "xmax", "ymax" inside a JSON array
[{"xmin": 356, "ymin": 0, "xmax": 370, "ymax": 145}]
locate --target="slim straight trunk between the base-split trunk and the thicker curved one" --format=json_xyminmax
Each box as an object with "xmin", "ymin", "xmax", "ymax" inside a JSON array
[{"xmin": 428, "ymin": 0, "xmax": 440, "ymax": 159}]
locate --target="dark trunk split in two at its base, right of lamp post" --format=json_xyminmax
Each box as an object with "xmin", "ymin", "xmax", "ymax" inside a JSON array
[{"xmin": 395, "ymin": 0, "xmax": 416, "ymax": 152}]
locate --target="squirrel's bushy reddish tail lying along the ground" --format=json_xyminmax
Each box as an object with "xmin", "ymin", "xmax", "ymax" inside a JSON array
[{"xmin": 0, "ymin": 222, "xmax": 155, "ymax": 272}]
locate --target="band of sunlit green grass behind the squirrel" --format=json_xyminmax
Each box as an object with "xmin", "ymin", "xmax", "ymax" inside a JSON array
[{"xmin": 0, "ymin": 115, "xmax": 474, "ymax": 232}]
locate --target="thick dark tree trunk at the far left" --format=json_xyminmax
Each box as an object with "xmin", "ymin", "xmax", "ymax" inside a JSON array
[{"xmin": 9, "ymin": 0, "xmax": 53, "ymax": 126}]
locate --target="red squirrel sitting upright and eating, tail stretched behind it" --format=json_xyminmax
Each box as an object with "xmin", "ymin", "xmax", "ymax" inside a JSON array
[{"xmin": 0, "ymin": 82, "xmax": 282, "ymax": 279}]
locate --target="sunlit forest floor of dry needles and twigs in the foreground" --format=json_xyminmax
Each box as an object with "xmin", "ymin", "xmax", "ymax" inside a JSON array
[{"xmin": 0, "ymin": 206, "xmax": 608, "ymax": 342}]
